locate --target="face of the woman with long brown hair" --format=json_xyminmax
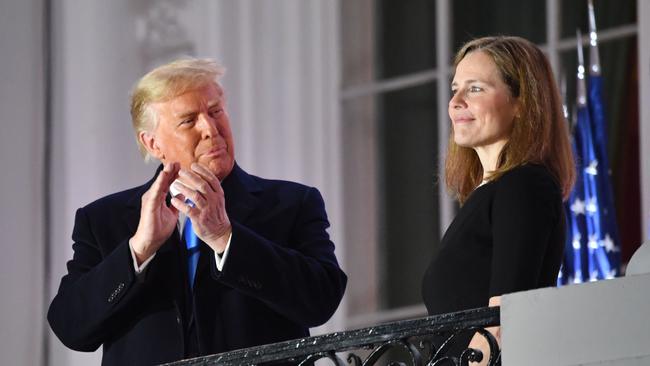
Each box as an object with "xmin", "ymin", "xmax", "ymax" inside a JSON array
[{"xmin": 449, "ymin": 51, "xmax": 518, "ymax": 154}]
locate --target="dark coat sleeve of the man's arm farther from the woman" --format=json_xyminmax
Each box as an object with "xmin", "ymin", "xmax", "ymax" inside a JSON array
[{"xmin": 47, "ymin": 208, "xmax": 145, "ymax": 351}]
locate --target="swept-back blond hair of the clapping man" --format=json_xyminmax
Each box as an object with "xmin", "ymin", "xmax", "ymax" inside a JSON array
[{"xmin": 131, "ymin": 58, "xmax": 226, "ymax": 161}]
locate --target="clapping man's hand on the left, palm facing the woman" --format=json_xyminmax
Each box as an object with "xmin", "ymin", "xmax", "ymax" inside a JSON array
[{"xmin": 129, "ymin": 163, "xmax": 180, "ymax": 265}]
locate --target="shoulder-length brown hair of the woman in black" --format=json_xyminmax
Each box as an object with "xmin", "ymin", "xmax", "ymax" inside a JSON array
[{"xmin": 445, "ymin": 36, "xmax": 575, "ymax": 203}]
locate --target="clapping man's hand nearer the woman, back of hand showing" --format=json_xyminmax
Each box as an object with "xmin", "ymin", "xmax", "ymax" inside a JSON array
[{"xmin": 171, "ymin": 163, "xmax": 232, "ymax": 254}]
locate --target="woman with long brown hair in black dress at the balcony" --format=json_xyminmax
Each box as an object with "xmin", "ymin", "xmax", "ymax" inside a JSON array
[{"xmin": 422, "ymin": 37, "xmax": 575, "ymax": 359}]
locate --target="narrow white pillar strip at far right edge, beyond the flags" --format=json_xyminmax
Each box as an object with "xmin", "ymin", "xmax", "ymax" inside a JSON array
[{"xmin": 636, "ymin": 0, "xmax": 650, "ymax": 241}]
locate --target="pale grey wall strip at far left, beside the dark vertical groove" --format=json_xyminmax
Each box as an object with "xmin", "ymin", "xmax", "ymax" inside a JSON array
[{"xmin": 0, "ymin": 0, "xmax": 45, "ymax": 365}]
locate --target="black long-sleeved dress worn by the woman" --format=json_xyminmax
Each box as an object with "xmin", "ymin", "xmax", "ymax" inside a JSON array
[{"xmin": 422, "ymin": 164, "xmax": 565, "ymax": 315}]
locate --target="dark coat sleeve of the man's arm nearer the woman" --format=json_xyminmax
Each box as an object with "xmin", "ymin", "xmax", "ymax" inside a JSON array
[{"xmin": 212, "ymin": 188, "xmax": 347, "ymax": 327}]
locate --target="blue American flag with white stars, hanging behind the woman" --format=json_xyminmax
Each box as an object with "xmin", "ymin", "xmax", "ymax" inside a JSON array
[{"xmin": 558, "ymin": 1, "xmax": 621, "ymax": 285}]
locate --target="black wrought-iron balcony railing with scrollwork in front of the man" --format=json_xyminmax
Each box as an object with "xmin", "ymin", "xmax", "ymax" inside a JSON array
[{"xmin": 167, "ymin": 307, "xmax": 501, "ymax": 366}]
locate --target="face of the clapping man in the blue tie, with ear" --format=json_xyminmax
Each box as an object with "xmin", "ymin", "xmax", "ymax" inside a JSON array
[{"xmin": 140, "ymin": 84, "xmax": 235, "ymax": 180}]
